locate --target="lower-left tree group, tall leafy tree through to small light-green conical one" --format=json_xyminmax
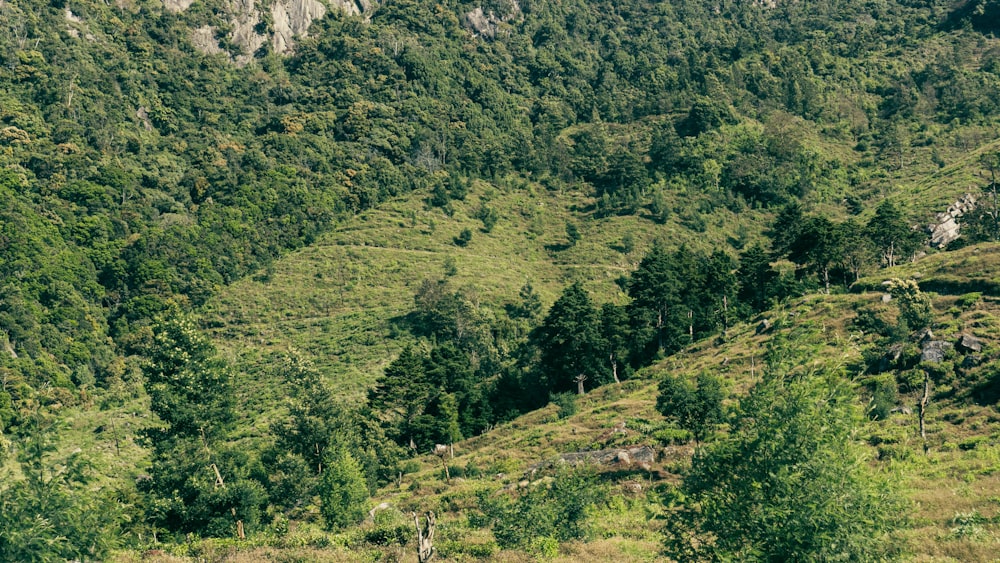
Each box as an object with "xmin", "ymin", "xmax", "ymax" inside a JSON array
[{"xmin": 124, "ymin": 316, "xmax": 403, "ymax": 538}]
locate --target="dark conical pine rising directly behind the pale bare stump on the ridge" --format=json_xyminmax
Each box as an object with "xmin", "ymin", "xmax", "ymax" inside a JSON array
[{"xmin": 531, "ymin": 282, "xmax": 607, "ymax": 396}]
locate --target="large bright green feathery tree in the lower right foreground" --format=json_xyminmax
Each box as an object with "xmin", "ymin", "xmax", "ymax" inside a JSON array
[{"xmin": 667, "ymin": 372, "xmax": 901, "ymax": 561}]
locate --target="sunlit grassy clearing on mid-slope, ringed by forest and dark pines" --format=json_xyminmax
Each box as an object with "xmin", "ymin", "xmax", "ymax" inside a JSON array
[{"xmin": 202, "ymin": 178, "xmax": 763, "ymax": 397}]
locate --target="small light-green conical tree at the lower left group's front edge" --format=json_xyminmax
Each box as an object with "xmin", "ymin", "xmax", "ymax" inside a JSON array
[{"xmin": 318, "ymin": 449, "xmax": 368, "ymax": 530}]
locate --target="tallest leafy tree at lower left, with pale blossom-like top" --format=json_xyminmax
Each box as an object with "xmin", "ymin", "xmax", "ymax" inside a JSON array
[{"xmin": 140, "ymin": 317, "xmax": 267, "ymax": 536}]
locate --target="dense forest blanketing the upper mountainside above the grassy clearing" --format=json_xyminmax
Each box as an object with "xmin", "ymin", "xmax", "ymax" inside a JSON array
[{"xmin": 0, "ymin": 0, "xmax": 1000, "ymax": 430}]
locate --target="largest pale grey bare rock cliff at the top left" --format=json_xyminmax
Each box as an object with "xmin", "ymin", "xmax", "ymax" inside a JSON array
[{"xmin": 163, "ymin": 0, "xmax": 374, "ymax": 65}]
